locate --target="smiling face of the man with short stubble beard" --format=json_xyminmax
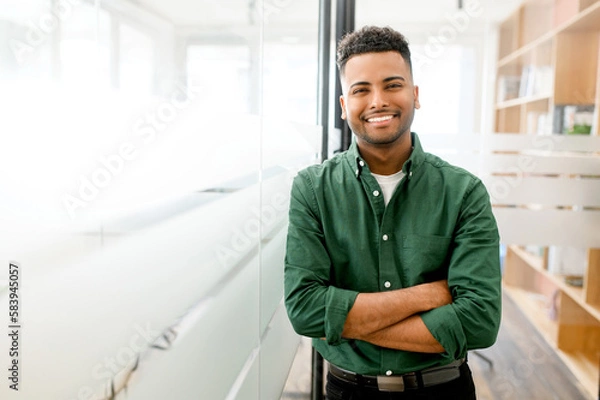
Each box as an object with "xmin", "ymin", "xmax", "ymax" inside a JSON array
[{"xmin": 340, "ymin": 51, "xmax": 420, "ymax": 145}]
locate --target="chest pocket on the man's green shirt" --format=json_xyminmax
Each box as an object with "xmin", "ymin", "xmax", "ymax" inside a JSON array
[{"xmin": 400, "ymin": 235, "xmax": 452, "ymax": 285}]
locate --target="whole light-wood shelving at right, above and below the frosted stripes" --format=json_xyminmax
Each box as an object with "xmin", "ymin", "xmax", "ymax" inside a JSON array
[{"xmin": 495, "ymin": 0, "xmax": 600, "ymax": 398}]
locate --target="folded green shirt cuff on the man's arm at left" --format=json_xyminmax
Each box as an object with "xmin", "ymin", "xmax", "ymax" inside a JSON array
[{"xmin": 325, "ymin": 286, "xmax": 358, "ymax": 346}]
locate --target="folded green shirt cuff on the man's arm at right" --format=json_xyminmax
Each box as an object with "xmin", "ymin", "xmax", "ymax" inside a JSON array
[{"xmin": 421, "ymin": 304, "xmax": 467, "ymax": 360}]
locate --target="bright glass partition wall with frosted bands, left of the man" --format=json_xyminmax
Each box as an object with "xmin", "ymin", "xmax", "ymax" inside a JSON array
[{"xmin": 0, "ymin": 0, "xmax": 321, "ymax": 399}]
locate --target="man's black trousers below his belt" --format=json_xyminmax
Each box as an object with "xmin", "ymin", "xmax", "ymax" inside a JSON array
[{"xmin": 326, "ymin": 362, "xmax": 476, "ymax": 400}]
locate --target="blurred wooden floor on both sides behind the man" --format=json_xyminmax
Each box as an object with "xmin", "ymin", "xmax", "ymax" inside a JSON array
[{"xmin": 281, "ymin": 295, "xmax": 595, "ymax": 400}]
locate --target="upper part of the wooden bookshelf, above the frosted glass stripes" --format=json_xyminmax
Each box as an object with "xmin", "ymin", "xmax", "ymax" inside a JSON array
[{"xmin": 495, "ymin": 0, "xmax": 600, "ymax": 134}]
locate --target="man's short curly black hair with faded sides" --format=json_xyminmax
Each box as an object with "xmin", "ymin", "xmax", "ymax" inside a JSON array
[{"xmin": 337, "ymin": 26, "xmax": 412, "ymax": 74}]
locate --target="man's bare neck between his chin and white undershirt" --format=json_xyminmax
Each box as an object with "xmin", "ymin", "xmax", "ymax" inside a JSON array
[{"xmin": 357, "ymin": 132, "xmax": 412, "ymax": 175}]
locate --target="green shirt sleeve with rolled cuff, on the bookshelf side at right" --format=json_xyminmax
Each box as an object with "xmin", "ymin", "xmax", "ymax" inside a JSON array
[{"xmin": 421, "ymin": 178, "xmax": 501, "ymax": 358}]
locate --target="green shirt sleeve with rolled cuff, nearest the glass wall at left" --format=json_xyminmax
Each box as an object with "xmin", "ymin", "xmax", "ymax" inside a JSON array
[{"xmin": 284, "ymin": 171, "xmax": 358, "ymax": 345}]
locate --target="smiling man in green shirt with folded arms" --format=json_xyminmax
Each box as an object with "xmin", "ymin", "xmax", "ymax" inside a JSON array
[{"xmin": 285, "ymin": 27, "xmax": 501, "ymax": 400}]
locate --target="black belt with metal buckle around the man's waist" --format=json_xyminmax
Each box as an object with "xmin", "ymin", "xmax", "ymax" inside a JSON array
[{"xmin": 329, "ymin": 358, "xmax": 465, "ymax": 392}]
